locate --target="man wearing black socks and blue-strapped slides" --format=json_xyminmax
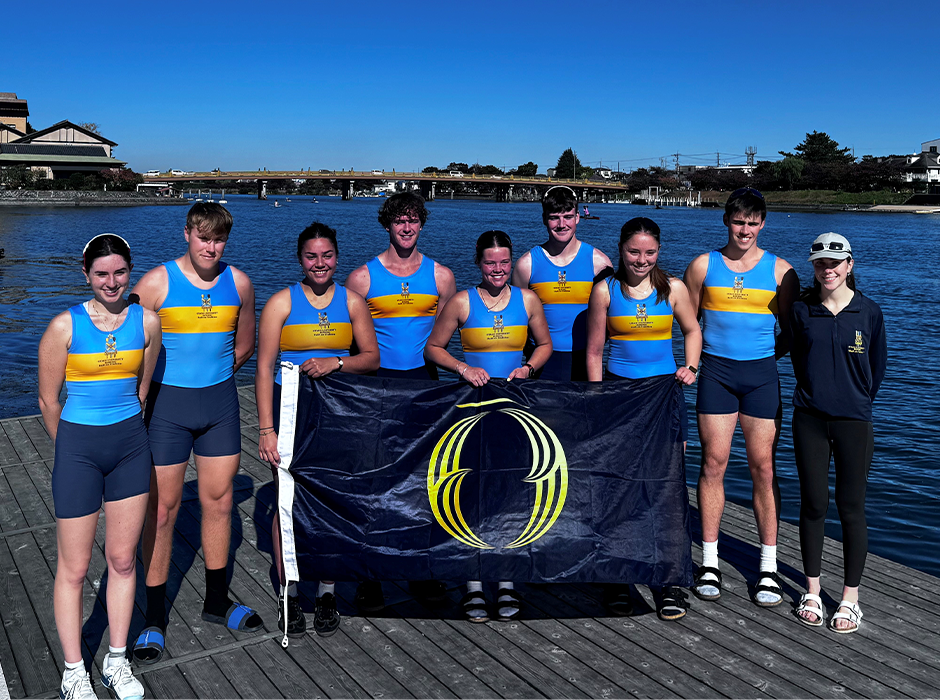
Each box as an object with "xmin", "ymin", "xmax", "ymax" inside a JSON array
[{"xmin": 134, "ymin": 203, "xmax": 263, "ymax": 663}]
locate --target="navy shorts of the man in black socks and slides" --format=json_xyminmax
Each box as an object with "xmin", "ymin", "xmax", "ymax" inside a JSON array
[{"xmin": 146, "ymin": 377, "xmax": 242, "ymax": 466}]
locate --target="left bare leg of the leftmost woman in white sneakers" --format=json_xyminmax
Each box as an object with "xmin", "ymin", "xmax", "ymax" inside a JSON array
[{"xmin": 52, "ymin": 511, "xmax": 99, "ymax": 663}]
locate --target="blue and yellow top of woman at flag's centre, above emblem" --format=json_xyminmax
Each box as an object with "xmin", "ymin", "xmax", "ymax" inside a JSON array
[{"xmin": 460, "ymin": 287, "xmax": 529, "ymax": 379}]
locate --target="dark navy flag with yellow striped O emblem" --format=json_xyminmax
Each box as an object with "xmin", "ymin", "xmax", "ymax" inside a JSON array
[{"xmin": 279, "ymin": 369, "xmax": 692, "ymax": 585}]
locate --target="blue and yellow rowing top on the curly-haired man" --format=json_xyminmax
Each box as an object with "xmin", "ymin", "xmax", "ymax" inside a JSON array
[{"xmin": 366, "ymin": 255, "xmax": 439, "ymax": 376}]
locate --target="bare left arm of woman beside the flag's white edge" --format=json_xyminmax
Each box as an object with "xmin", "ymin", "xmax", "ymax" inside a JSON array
[{"xmin": 255, "ymin": 289, "xmax": 291, "ymax": 465}]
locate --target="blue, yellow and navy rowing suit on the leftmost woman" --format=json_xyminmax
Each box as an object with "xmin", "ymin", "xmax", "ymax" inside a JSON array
[{"xmin": 52, "ymin": 304, "xmax": 150, "ymax": 518}]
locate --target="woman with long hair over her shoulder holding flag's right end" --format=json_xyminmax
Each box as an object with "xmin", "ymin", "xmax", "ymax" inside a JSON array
[{"xmin": 587, "ymin": 217, "xmax": 702, "ymax": 620}]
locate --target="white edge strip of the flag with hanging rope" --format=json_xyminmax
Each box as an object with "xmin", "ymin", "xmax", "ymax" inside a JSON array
[{"xmin": 277, "ymin": 362, "xmax": 300, "ymax": 649}]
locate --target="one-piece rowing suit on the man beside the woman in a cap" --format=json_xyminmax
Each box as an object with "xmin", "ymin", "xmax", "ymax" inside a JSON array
[{"xmin": 697, "ymin": 250, "xmax": 781, "ymax": 418}]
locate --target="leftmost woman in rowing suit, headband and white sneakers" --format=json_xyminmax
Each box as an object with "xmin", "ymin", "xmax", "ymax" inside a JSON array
[{"xmin": 39, "ymin": 233, "xmax": 160, "ymax": 700}]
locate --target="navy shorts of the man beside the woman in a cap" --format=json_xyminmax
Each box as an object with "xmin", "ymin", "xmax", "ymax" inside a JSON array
[{"xmin": 696, "ymin": 353, "xmax": 782, "ymax": 420}]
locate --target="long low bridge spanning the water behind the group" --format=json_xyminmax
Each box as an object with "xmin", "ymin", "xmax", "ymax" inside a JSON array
[{"xmin": 144, "ymin": 170, "xmax": 627, "ymax": 202}]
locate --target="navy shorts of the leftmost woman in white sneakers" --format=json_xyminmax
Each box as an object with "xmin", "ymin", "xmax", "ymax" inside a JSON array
[{"xmin": 52, "ymin": 413, "xmax": 152, "ymax": 518}]
